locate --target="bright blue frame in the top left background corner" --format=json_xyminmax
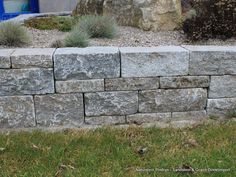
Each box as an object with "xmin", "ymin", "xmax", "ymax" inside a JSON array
[{"xmin": 0, "ymin": 0, "xmax": 39, "ymax": 21}]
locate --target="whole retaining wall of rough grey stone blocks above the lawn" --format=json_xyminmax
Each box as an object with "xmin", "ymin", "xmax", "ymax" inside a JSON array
[{"xmin": 0, "ymin": 46, "xmax": 236, "ymax": 128}]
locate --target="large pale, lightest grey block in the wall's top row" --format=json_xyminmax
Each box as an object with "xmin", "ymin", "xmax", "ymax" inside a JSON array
[{"xmin": 120, "ymin": 47, "xmax": 189, "ymax": 77}]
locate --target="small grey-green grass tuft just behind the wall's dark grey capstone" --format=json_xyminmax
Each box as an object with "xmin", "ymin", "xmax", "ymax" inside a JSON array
[{"xmin": 64, "ymin": 26, "xmax": 89, "ymax": 47}]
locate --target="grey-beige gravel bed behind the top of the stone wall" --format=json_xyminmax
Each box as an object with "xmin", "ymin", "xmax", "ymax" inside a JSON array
[{"xmin": 0, "ymin": 27, "xmax": 236, "ymax": 48}]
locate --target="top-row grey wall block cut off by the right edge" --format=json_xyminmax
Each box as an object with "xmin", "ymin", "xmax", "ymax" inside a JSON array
[{"xmin": 184, "ymin": 46, "xmax": 236, "ymax": 75}]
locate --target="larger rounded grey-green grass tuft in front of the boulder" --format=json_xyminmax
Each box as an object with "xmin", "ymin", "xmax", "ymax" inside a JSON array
[{"xmin": 77, "ymin": 15, "xmax": 117, "ymax": 39}]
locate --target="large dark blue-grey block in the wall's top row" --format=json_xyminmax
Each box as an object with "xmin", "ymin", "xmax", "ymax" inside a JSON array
[{"xmin": 54, "ymin": 47, "xmax": 120, "ymax": 80}]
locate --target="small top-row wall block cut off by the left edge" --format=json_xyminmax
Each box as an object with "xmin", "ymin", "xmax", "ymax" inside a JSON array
[{"xmin": 0, "ymin": 49, "xmax": 14, "ymax": 69}]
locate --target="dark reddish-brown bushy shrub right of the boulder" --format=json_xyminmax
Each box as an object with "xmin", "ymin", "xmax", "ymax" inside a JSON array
[{"xmin": 183, "ymin": 0, "xmax": 236, "ymax": 41}]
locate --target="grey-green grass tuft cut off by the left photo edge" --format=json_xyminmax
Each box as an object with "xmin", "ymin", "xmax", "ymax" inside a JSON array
[{"xmin": 0, "ymin": 22, "xmax": 30, "ymax": 47}]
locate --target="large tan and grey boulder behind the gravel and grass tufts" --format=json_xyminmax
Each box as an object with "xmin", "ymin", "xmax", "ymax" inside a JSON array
[{"xmin": 74, "ymin": 0, "xmax": 182, "ymax": 31}]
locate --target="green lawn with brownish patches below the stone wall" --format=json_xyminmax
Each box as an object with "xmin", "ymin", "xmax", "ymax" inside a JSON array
[{"xmin": 0, "ymin": 122, "xmax": 236, "ymax": 177}]
